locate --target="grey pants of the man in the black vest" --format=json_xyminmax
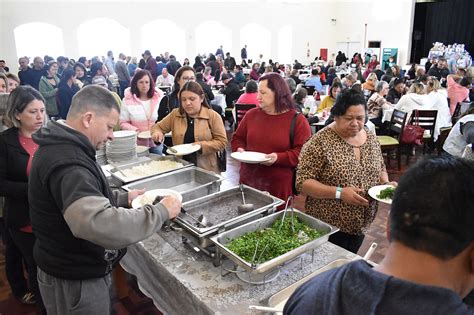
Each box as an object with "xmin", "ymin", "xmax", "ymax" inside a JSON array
[{"xmin": 38, "ymin": 268, "xmax": 111, "ymax": 315}]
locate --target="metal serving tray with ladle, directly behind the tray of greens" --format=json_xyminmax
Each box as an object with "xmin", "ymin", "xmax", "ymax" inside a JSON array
[{"xmin": 176, "ymin": 185, "xmax": 283, "ymax": 238}]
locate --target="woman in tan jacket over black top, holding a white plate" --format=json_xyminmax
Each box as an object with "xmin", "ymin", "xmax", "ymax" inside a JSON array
[{"xmin": 151, "ymin": 81, "xmax": 227, "ymax": 173}]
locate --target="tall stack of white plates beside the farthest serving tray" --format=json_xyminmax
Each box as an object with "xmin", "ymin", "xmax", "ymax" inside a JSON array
[{"xmin": 105, "ymin": 130, "xmax": 137, "ymax": 163}]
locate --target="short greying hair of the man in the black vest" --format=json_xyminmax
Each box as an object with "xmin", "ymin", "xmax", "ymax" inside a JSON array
[{"xmin": 67, "ymin": 85, "xmax": 120, "ymax": 118}]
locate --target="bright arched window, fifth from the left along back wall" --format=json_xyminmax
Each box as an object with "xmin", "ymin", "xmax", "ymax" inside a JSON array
[{"xmin": 240, "ymin": 23, "xmax": 272, "ymax": 62}]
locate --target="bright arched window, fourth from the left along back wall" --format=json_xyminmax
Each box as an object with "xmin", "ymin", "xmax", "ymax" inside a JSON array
[{"xmin": 196, "ymin": 21, "xmax": 232, "ymax": 54}]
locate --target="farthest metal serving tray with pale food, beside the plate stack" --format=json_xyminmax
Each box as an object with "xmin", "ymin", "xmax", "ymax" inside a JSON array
[{"xmin": 109, "ymin": 154, "xmax": 193, "ymax": 184}]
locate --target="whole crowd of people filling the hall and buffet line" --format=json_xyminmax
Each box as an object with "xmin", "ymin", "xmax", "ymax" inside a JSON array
[{"xmin": 0, "ymin": 46, "xmax": 474, "ymax": 314}]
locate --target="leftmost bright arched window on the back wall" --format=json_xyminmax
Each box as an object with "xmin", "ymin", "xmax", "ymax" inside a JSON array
[{"xmin": 13, "ymin": 22, "xmax": 64, "ymax": 61}]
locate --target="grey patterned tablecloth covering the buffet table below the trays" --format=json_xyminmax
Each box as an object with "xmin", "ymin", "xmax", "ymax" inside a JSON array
[{"xmin": 121, "ymin": 231, "xmax": 356, "ymax": 315}]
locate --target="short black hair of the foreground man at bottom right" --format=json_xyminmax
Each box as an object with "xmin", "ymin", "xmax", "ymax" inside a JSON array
[{"xmin": 390, "ymin": 155, "xmax": 474, "ymax": 260}]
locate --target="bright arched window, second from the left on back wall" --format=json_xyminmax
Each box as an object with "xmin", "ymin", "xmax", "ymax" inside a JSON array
[{"xmin": 77, "ymin": 18, "xmax": 130, "ymax": 58}]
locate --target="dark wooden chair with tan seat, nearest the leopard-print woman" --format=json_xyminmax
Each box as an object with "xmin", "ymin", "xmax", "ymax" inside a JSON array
[{"xmin": 377, "ymin": 109, "xmax": 407, "ymax": 171}]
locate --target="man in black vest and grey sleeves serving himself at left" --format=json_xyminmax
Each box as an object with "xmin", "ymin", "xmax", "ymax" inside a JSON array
[{"xmin": 28, "ymin": 85, "xmax": 181, "ymax": 314}]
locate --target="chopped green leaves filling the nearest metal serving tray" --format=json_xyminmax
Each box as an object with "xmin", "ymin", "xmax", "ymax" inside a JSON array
[{"xmin": 226, "ymin": 216, "xmax": 323, "ymax": 264}]
